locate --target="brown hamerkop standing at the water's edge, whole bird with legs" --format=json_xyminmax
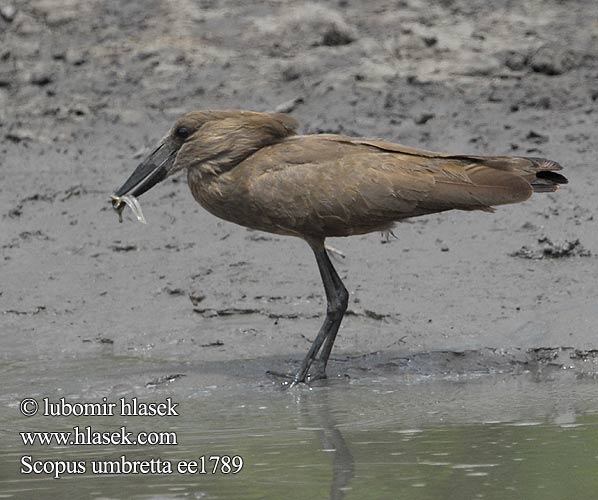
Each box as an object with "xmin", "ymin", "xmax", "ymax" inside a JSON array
[{"xmin": 113, "ymin": 110, "xmax": 567, "ymax": 385}]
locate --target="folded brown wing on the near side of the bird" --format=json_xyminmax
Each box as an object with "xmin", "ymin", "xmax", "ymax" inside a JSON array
[{"xmin": 244, "ymin": 136, "xmax": 532, "ymax": 227}]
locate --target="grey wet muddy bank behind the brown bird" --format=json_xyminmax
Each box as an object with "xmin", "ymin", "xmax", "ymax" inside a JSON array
[{"xmin": 0, "ymin": 0, "xmax": 598, "ymax": 380}]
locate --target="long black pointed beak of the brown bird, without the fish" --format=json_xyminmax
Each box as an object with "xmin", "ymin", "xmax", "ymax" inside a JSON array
[{"xmin": 112, "ymin": 138, "xmax": 178, "ymax": 201}]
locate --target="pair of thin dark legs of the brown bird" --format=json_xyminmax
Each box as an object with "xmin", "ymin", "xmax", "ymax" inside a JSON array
[{"xmin": 291, "ymin": 240, "xmax": 349, "ymax": 386}]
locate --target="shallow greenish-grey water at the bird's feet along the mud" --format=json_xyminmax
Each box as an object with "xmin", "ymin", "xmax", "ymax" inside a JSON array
[{"xmin": 0, "ymin": 359, "xmax": 598, "ymax": 500}]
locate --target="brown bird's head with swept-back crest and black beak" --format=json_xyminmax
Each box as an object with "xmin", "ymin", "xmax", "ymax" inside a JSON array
[{"xmin": 112, "ymin": 110, "xmax": 297, "ymax": 213}]
